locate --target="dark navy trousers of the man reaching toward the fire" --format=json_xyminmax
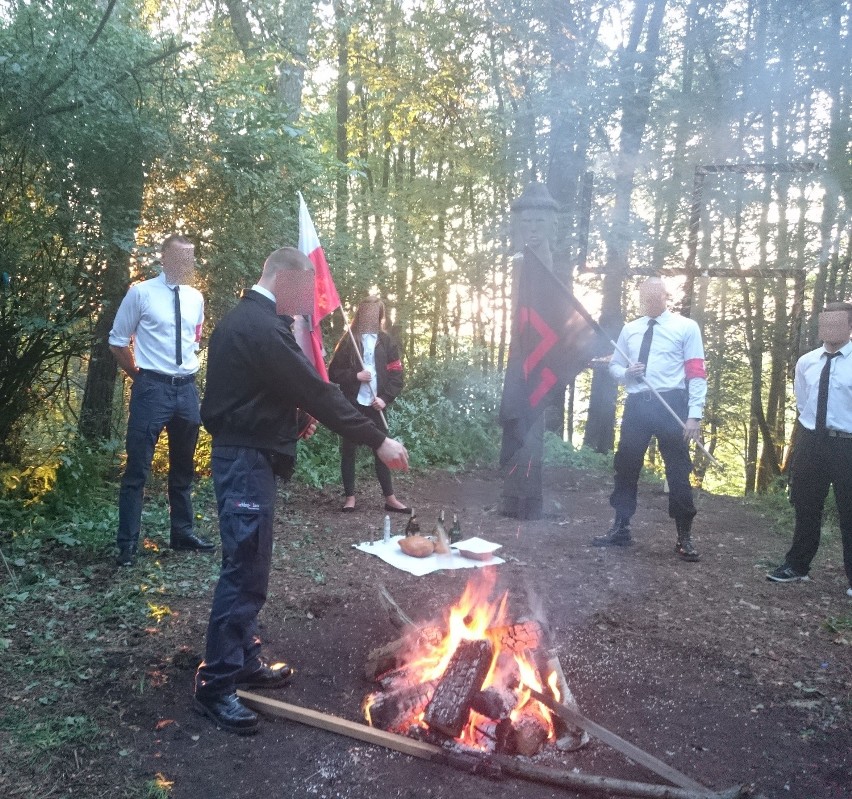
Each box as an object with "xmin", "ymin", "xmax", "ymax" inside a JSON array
[{"xmin": 195, "ymin": 447, "xmax": 275, "ymax": 696}]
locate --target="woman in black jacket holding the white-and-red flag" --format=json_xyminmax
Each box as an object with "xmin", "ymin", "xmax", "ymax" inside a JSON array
[{"xmin": 328, "ymin": 297, "xmax": 411, "ymax": 513}]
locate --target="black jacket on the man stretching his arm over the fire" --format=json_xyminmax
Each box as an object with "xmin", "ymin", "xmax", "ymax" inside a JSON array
[{"xmin": 201, "ymin": 291, "xmax": 386, "ymax": 456}]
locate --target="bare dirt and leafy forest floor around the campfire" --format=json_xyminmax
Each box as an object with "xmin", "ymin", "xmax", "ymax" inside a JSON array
[{"xmin": 0, "ymin": 468, "xmax": 852, "ymax": 799}]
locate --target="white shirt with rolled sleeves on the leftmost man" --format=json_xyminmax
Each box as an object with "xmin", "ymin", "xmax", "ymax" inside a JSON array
[{"xmin": 109, "ymin": 274, "xmax": 204, "ymax": 376}]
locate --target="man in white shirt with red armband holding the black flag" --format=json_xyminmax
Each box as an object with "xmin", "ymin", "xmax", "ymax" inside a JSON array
[{"xmin": 592, "ymin": 277, "xmax": 707, "ymax": 562}]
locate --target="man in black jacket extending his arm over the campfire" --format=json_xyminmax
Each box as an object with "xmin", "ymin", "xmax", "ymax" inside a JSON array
[{"xmin": 195, "ymin": 247, "xmax": 408, "ymax": 734}]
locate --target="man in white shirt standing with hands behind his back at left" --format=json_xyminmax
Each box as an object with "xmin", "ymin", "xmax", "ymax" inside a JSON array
[{"xmin": 109, "ymin": 235, "xmax": 215, "ymax": 566}]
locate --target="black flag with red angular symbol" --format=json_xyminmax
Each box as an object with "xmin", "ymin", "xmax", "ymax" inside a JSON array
[{"xmin": 500, "ymin": 249, "xmax": 596, "ymax": 466}]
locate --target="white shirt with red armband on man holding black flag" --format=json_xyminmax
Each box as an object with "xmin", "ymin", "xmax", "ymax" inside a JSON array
[{"xmin": 609, "ymin": 311, "xmax": 707, "ymax": 419}]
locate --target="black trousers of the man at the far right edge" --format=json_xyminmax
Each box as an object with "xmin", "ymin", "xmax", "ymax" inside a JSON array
[{"xmin": 785, "ymin": 425, "xmax": 852, "ymax": 586}]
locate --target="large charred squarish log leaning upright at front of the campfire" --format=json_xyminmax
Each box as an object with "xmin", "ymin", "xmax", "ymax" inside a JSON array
[{"xmin": 423, "ymin": 640, "xmax": 492, "ymax": 738}]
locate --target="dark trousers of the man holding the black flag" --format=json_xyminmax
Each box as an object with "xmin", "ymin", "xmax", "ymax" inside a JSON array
[{"xmin": 609, "ymin": 391, "xmax": 695, "ymax": 521}]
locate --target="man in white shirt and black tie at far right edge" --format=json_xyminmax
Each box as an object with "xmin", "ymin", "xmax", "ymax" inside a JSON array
[{"xmin": 766, "ymin": 302, "xmax": 852, "ymax": 596}]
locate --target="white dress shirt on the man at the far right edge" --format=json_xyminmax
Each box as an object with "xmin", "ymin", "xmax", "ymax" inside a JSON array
[{"xmin": 793, "ymin": 341, "xmax": 852, "ymax": 433}]
